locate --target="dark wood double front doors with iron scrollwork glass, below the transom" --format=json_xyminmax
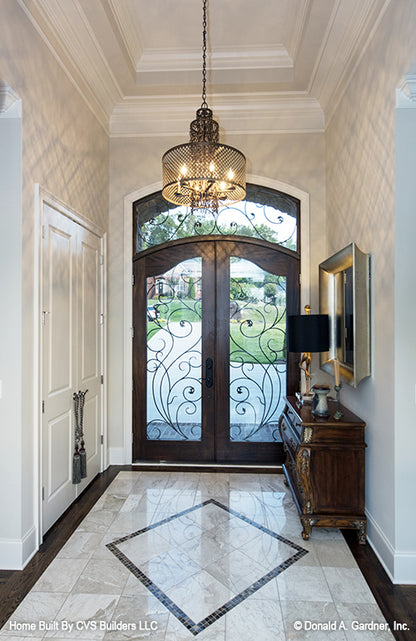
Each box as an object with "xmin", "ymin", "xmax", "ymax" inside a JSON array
[{"xmin": 133, "ymin": 236, "xmax": 299, "ymax": 463}]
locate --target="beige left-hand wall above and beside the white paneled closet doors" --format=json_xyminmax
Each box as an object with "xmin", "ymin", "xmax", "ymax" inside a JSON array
[{"xmin": 0, "ymin": 0, "xmax": 109, "ymax": 552}]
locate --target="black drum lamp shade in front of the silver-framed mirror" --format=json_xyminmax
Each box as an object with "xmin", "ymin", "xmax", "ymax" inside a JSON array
[{"xmin": 287, "ymin": 314, "xmax": 329, "ymax": 352}]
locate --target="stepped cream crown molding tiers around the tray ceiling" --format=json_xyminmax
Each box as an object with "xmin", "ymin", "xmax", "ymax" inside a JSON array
[{"xmin": 13, "ymin": 0, "xmax": 390, "ymax": 136}]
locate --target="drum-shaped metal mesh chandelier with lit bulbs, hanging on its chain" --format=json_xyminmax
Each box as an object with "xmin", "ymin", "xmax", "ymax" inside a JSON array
[{"xmin": 162, "ymin": 0, "xmax": 246, "ymax": 212}]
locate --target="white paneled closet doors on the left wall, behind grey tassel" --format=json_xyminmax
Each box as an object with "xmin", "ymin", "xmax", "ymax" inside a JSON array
[{"xmin": 41, "ymin": 203, "xmax": 102, "ymax": 533}]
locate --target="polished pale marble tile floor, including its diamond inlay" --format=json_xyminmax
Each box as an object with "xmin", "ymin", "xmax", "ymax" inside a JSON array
[{"xmin": 0, "ymin": 471, "xmax": 393, "ymax": 641}]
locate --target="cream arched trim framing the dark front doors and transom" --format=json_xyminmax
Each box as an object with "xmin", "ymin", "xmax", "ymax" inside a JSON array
[{"xmin": 120, "ymin": 174, "xmax": 310, "ymax": 465}]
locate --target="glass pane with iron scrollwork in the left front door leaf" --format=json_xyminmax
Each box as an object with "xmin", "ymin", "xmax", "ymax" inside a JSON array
[{"xmin": 146, "ymin": 257, "xmax": 202, "ymax": 442}]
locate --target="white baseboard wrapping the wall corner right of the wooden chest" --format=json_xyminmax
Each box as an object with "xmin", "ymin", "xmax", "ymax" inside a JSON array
[{"xmin": 367, "ymin": 512, "xmax": 416, "ymax": 585}]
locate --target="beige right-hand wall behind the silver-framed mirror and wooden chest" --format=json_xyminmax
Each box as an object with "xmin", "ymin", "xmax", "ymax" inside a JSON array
[{"xmin": 326, "ymin": 0, "xmax": 416, "ymax": 574}]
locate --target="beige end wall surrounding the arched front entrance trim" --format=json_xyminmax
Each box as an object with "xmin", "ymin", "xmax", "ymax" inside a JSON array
[{"xmin": 108, "ymin": 130, "xmax": 326, "ymax": 448}]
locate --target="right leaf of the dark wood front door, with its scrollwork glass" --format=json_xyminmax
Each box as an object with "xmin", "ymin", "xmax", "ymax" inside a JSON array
[{"xmin": 215, "ymin": 240, "xmax": 299, "ymax": 463}]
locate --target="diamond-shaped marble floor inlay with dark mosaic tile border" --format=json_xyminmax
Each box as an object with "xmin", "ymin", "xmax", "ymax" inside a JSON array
[{"xmin": 107, "ymin": 499, "xmax": 307, "ymax": 636}]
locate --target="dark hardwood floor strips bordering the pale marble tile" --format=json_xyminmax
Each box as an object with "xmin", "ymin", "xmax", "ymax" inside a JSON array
[{"xmin": 0, "ymin": 465, "xmax": 416, "ymax": 641}]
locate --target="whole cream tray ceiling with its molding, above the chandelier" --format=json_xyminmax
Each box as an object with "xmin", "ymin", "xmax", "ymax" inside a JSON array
[{"xmin": 18, "ymin": 0, "xmax": 390, "ymax": 136}]
